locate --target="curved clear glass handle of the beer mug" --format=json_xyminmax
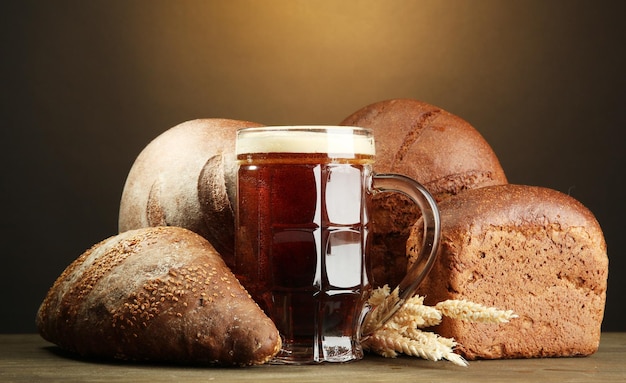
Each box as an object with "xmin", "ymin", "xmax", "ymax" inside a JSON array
[{"xmin": 361, "ymin": 174, "xmax": 441, "ymax": 339}]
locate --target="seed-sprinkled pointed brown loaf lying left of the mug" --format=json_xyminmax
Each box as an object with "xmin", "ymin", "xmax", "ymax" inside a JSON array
[{"xmin": 36, "ymin": 227, "xmax": 281, "ymax": 365}]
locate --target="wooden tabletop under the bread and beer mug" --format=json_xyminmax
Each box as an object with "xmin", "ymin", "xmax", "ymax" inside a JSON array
[{"xmin": 0, "ymin": 333, "xmax": 626, "ymax": 383}]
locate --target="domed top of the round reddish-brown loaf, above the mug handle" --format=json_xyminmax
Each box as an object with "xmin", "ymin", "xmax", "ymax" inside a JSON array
[{"xmin": 340, "ymin": 99, "xmax": 507, "ymax": 199}]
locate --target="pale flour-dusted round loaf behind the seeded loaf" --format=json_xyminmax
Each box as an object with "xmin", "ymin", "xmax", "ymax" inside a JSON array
[{"xmin": 119, "ymin": 118, "xmax": 261, "ymax": 267}]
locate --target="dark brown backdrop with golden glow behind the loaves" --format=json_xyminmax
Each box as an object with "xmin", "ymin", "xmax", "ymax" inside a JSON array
[{"xmin": 0, "ymin": 0, "xmax": 626, "ymax": 332}]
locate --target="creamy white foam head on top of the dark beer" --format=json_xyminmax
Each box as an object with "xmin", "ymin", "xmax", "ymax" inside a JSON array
[{"xmin": 236, "ymin": 125, "xmax": 376, "ymax": 156}]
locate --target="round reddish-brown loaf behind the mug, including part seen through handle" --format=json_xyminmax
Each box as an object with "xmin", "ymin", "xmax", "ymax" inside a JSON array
[{"xmin": 340, "ymin": 99, "xmax": 507, "ymax": 286}]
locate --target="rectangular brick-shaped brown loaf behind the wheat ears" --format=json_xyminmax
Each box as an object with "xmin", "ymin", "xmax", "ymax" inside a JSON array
[{"xmin": 408, "ymin": 184, "xmax": 608, "ymax": 359}]
